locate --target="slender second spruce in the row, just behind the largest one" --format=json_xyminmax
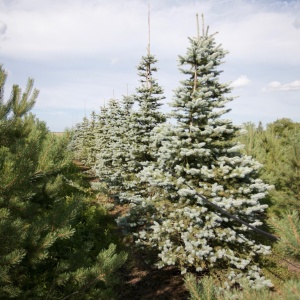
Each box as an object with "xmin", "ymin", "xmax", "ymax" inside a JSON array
[{"xmin": 120, "ymin": 44, "xmax": 166, "ymax": 202}]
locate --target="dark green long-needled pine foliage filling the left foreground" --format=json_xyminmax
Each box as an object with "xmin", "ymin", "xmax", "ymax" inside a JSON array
[{"xmin": 0, "ymin": 69, "xmax": 126, "ymax": 299}]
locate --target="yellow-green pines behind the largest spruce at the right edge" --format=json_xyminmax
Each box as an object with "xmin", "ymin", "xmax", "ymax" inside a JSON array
[{"xmin": 238, "ymin": 119, "xmax": 300, "ymax": 214}]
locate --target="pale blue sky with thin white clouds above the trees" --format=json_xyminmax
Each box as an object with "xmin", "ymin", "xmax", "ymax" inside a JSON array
[{"xmin": 0, "ymin": 0, "xmax": 300, "ymax": 131}]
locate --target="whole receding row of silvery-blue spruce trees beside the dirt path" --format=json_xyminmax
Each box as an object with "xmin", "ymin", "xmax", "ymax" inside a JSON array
[{"xmin": 70, "ymin": 24, "xmax": 284, "ymax": 290}]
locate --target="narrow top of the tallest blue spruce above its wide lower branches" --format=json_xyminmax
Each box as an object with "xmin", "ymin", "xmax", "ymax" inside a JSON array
[{"xmin": 171, "ymin": 24, "xmax": 233, "ymax": 134}]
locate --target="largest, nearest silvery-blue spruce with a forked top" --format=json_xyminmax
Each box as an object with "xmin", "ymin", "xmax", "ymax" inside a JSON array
[{"xmin": 121, "ymin": 18, "xmax": 271, "ymax": 288}]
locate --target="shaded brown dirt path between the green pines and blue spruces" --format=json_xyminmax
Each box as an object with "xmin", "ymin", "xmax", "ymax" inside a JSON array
[{"xmin": 74, "ymin": 161, "xmax": 189, "ymax": 300}]
